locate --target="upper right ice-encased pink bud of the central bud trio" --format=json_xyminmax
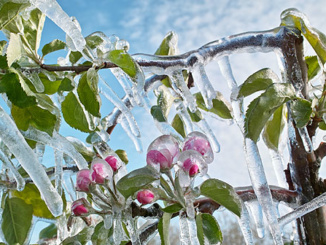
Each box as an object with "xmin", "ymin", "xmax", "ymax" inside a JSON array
[{"xmin": 183, "ymin": 132, "xmax": 214, "ymax": 163}]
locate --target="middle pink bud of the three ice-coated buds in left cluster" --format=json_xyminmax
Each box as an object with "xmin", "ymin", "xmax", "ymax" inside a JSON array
[{"xmin": 91, "ymin": 158, "xmax": 113, "ymax": 184}]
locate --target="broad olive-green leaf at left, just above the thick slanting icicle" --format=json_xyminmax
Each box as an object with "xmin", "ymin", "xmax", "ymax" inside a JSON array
[{"xmin": 11, "ymin": 105, "xmax": 57, "ymax": 136}]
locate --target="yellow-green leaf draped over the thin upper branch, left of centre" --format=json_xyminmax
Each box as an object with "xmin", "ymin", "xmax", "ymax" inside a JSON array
[{"xmin": 108, "ymin": 50, "xmax": 138, "ymax": 78}]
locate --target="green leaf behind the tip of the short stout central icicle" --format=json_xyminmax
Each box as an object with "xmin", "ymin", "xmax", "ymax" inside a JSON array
[{"xmin": 195, "ymin": 92, "xmax": 232, "ymax": 119}]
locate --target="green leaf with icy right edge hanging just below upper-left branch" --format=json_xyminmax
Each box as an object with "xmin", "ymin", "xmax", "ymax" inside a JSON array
[{"xmin": 77, "ymin": 68, "xmax": 101, "ymax": 117}]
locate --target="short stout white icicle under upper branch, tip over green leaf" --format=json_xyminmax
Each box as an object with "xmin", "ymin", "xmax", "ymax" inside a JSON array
[{"xmin": 192, "ymin": 64, "xmax": 216, "ymax": 109}]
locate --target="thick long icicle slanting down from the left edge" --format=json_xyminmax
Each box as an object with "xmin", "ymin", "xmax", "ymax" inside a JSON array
[{"xmin": 0, "ymin": 107, "xmax": 63, "ymax": 216}]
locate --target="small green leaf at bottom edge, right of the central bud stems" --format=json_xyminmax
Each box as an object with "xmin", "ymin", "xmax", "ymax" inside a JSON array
[{"xmin": 196, "ymin": 213, "xmax": 223, "ymax": 245}]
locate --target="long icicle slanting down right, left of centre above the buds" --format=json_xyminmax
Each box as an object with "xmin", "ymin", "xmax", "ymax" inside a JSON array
[{"xmin": 100, "ymin": 79, "xmax": 140, "ymax": 137}]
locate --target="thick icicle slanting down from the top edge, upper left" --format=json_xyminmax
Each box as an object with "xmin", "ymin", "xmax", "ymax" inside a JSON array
[{"xmin": 30, "ymin": 0, "xmax": 86, "ymax": 52}]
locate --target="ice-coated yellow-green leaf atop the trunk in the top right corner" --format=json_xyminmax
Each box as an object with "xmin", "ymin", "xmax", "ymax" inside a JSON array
[{"xmin": 281, "ymin": 8, "xmax": 326, "ymax": 64}]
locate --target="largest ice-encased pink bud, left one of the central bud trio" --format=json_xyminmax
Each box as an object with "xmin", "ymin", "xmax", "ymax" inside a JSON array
[{"xmin": 146, "ymin": 135, "xmax": 180, "ymax": 171}]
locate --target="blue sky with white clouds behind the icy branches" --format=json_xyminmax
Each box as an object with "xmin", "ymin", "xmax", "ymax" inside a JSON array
[{"xmin": 3, "ymin": 0, "xmax": 326, "ymax": 241}]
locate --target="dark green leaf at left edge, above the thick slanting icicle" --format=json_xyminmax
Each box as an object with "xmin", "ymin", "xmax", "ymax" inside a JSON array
[{"xmin": 0, "ymin": 73, "xmax": 36, "ymax": 108}]
